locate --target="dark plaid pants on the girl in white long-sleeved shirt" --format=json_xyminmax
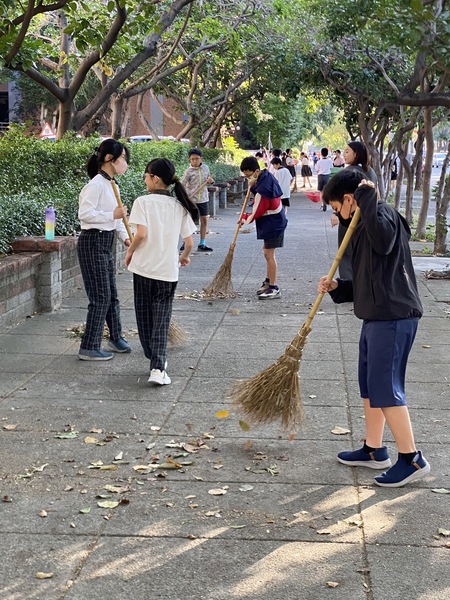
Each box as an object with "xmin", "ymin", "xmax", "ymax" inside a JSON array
[{"xmin": 77, "ymin": 229, "xmax": 122, "ymax": 350}]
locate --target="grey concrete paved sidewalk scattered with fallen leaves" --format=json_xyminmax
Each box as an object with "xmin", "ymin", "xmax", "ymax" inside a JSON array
[{"xmin": 0, "ymin": 193, "xmax": 450, "ymax": 600}]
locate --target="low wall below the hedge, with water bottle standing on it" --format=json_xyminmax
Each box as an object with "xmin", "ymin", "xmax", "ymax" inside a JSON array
[{"xmin": 0, "ymin": 237, "xmax": 124, "ymax": 326}]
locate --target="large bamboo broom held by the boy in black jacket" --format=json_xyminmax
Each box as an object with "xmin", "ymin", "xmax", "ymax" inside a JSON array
[{"xmin": 229, "ymin": 208, "xmax": 360, "ymax": 437}]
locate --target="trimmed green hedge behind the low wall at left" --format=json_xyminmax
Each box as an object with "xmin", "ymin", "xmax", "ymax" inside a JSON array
[{"xmin": 0, "ymin": 126, "xmax": 242, "ymax": 254}]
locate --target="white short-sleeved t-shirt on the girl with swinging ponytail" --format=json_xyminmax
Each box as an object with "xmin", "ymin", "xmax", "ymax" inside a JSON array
[{"xmin": 128, "ymin": 194, "xmax": 197, "ymax": 281}]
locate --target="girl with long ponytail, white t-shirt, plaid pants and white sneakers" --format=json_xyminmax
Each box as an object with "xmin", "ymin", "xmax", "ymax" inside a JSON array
[{"xmin": 125, "ymin": 158, "xmax": 198, "ymax": 385}]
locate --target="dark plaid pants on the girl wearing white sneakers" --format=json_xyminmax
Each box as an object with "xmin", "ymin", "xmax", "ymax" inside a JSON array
[{"xmin": 133, "ymin": 273, "xmax": 178, "ymax": 371}]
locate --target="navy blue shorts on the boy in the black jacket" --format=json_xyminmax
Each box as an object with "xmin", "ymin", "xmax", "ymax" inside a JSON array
[{"xmin": 358, "ymin": 318, "xmax": 419, "ymax": 408}]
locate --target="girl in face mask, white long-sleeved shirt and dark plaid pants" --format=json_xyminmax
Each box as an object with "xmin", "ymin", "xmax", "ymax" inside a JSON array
[{"xmin": 77, "ymin": 139, "xmax": 131, "ymax": 360}]
